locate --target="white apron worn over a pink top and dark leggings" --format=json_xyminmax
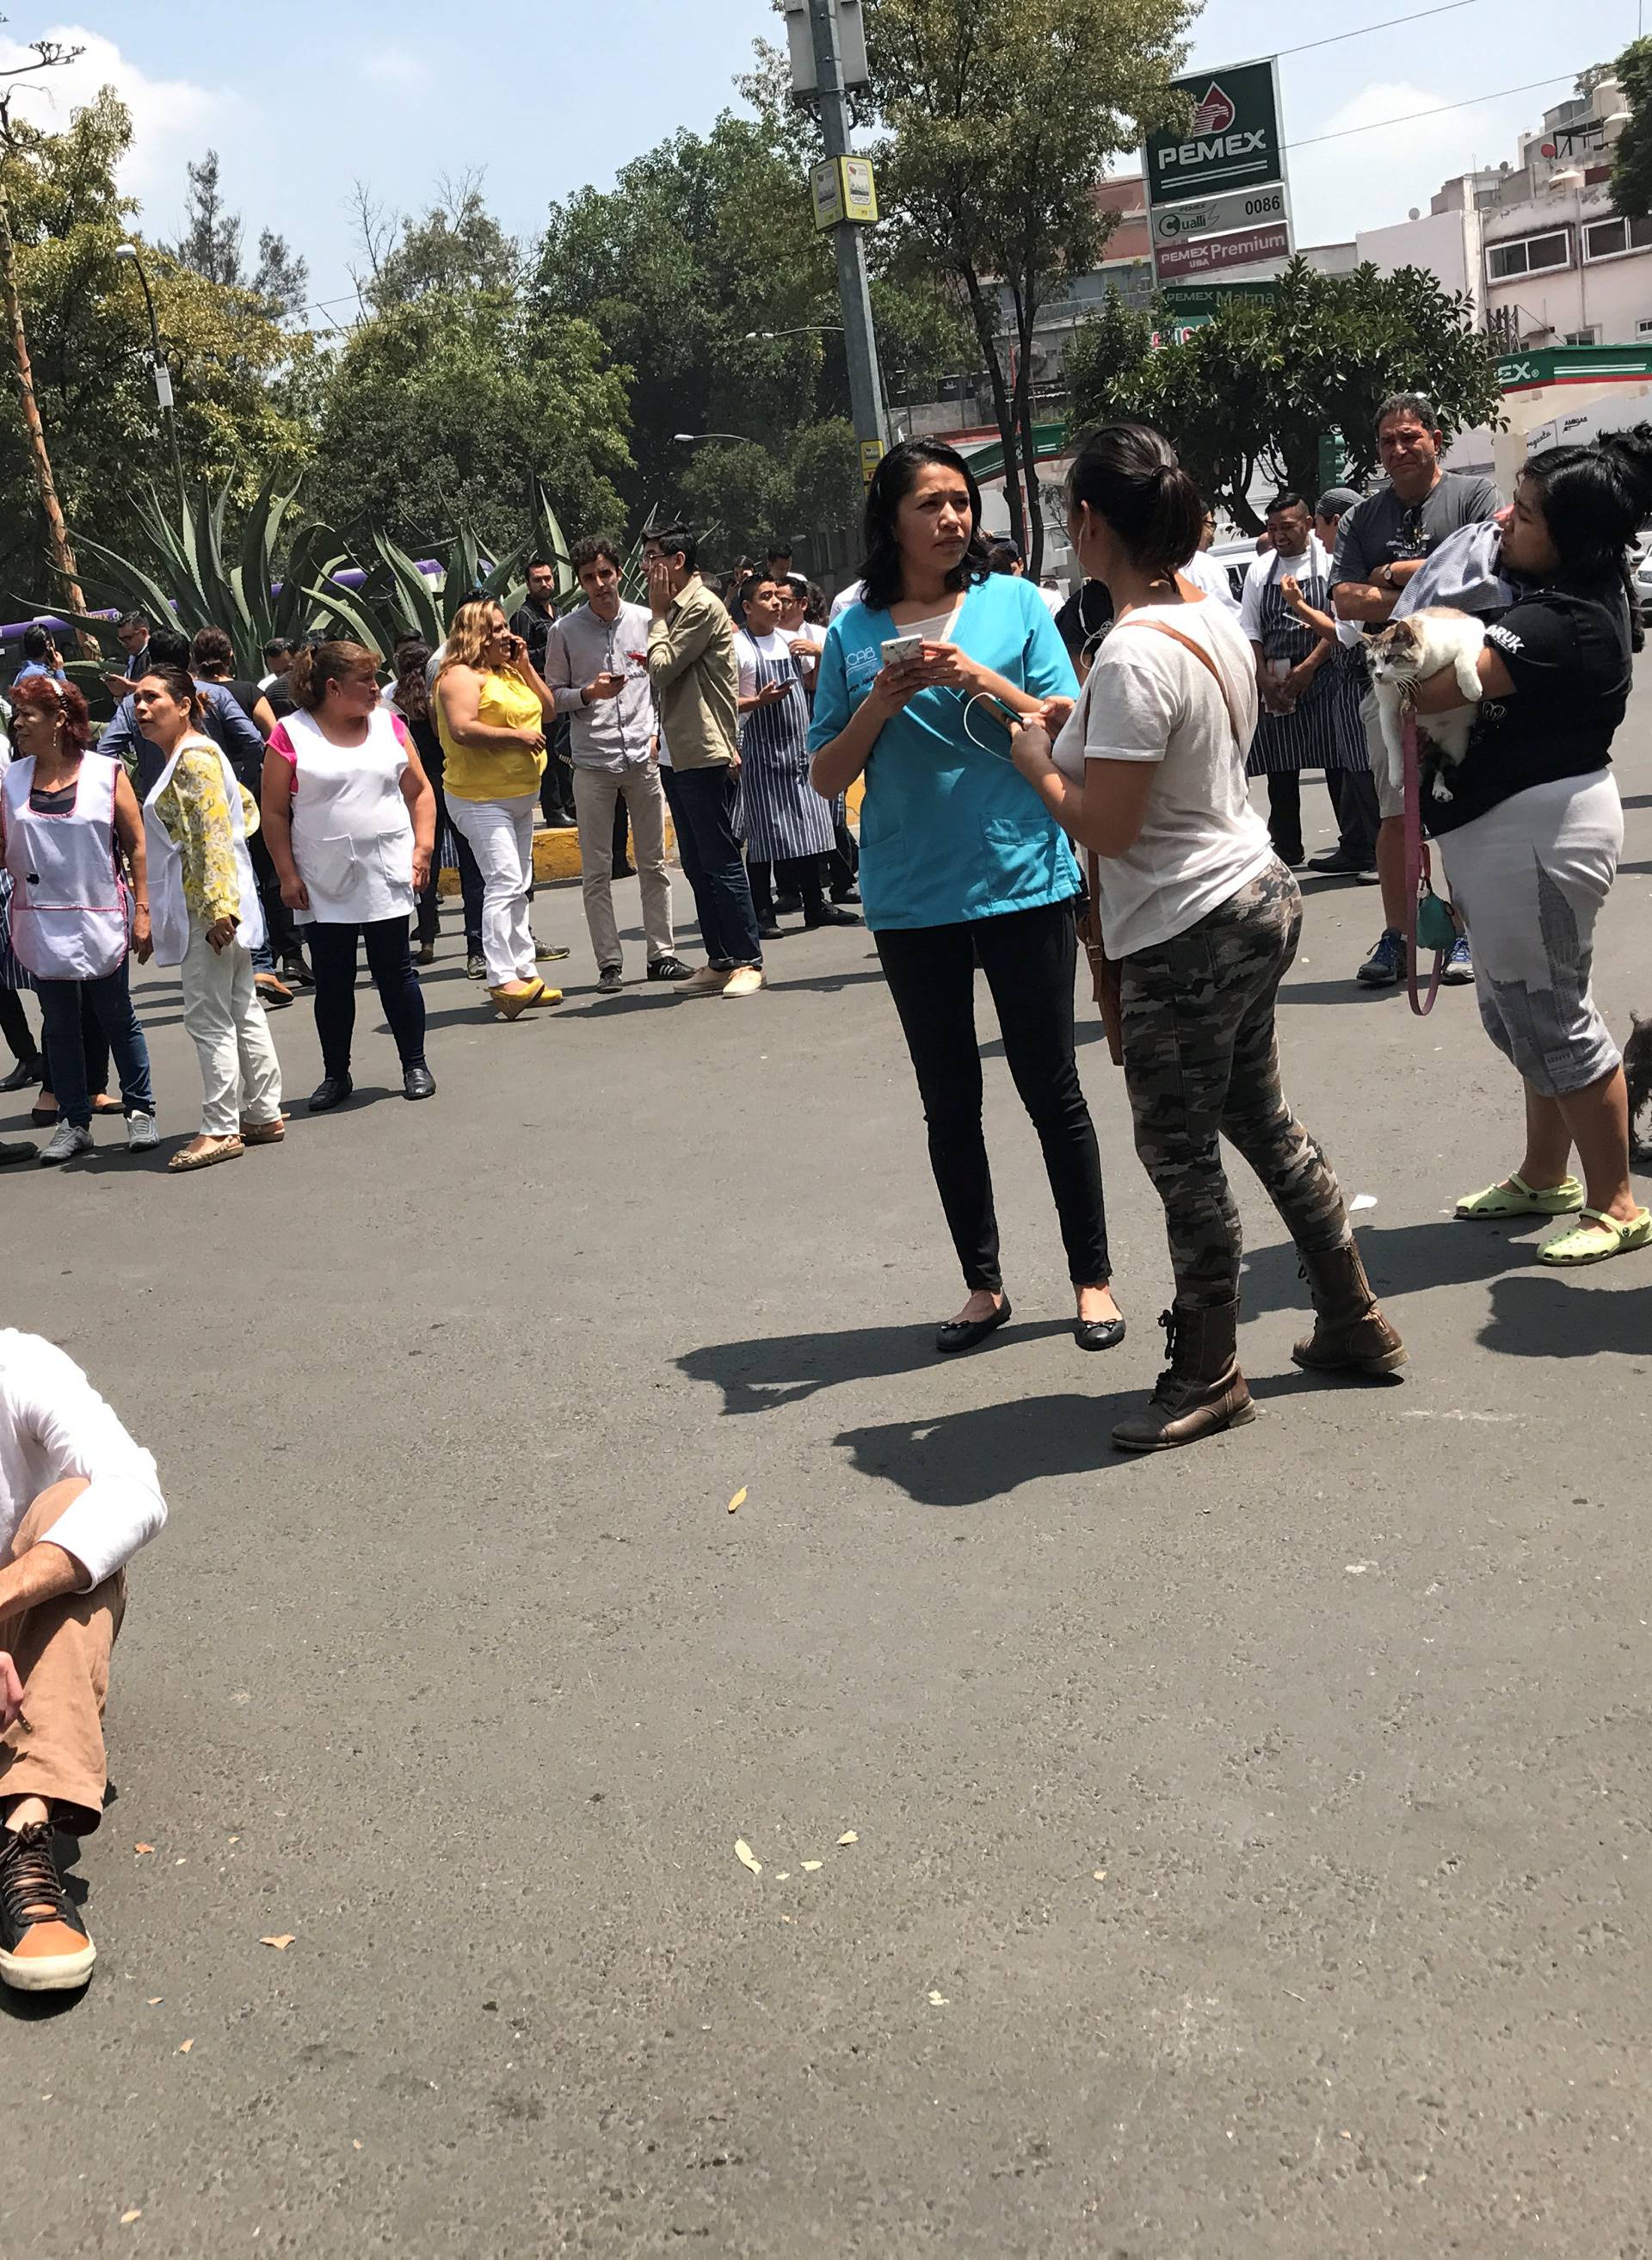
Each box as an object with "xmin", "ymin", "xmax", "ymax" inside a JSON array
[{"xmin": 285, "ymin": 707, "xmax": 414, "ymax": 927}]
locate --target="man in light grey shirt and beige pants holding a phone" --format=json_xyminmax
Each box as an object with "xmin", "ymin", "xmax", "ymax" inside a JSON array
[{"xmin": 540, "ymin": 534, "xmax": 692, "ymax": 997}]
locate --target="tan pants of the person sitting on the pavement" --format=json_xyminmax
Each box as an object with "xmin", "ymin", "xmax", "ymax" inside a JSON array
[{"xmin": 0, "ymin": 1498, "xmax": 126, "ymax": 1835}]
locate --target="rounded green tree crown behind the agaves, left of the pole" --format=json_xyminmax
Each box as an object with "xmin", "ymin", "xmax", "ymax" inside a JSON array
[{"xmin": 307, "ymin": 289, "xmax": 631, "ymax": 556}]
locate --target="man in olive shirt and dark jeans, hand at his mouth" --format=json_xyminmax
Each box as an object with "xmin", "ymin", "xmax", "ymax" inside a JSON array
[{"xmin": 644, "ymin": 527, "xmax": 764, "ymax": 997}]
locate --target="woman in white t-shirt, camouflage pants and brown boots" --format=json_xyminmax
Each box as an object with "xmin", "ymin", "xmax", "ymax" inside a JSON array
[{"xmin": 1014, "ymin": 425, "xmax": 1406, "ymax": 1451}]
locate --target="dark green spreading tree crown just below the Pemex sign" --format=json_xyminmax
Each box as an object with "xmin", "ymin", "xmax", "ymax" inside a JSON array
[{"xmin": 1067, "ymin": 257, "xmax": 1501, "ymax": 534}]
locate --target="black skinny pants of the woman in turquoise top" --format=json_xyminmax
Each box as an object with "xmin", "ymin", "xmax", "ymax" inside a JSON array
[{"xmin": 874, "ymin": 902, "xmax": 1112, "ymax": 1293}]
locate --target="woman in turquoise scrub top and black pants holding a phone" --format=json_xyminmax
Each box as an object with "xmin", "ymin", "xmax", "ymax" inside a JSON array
[{"xmin": 809, "ymin": 441, "xmax": 1123, "ymax": 1351}]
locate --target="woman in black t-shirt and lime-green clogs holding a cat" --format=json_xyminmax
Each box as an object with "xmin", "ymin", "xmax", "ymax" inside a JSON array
[{"xmin": 1410, "ymin": 425, "xmax": 1652, "ymax": 1266}]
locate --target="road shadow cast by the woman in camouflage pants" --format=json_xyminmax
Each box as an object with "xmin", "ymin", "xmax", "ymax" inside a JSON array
[{"xmin": 834, "ymin": 1374, "xmax": 1324, "ymax": 1508}]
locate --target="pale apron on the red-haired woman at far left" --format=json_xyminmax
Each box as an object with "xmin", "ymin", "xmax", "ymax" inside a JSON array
[{"xmin": 4, "ymin": 752, "xmax": 131, "ymax": 981}]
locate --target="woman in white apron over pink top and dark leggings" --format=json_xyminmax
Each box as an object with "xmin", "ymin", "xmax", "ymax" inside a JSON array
[{"xmin": 262, "ymin": 638, "xmax": 436, "ymax": 1115}]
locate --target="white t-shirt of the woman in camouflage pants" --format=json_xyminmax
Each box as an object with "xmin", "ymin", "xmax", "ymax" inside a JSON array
[{"xmin": 1053, "ymin": 602, "xmax": 1273, "ymax": 958}]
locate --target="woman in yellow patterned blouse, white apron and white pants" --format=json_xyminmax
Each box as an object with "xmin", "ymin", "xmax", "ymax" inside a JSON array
[{"xmin": 131, "ymin": 667, "xmax": 285, "ymax": 1170}]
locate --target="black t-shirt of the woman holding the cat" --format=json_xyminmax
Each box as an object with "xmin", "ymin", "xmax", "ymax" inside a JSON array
[{"xmin": 1421, "ymin": 581, "xmax": 1630, "ymax": 838}]
